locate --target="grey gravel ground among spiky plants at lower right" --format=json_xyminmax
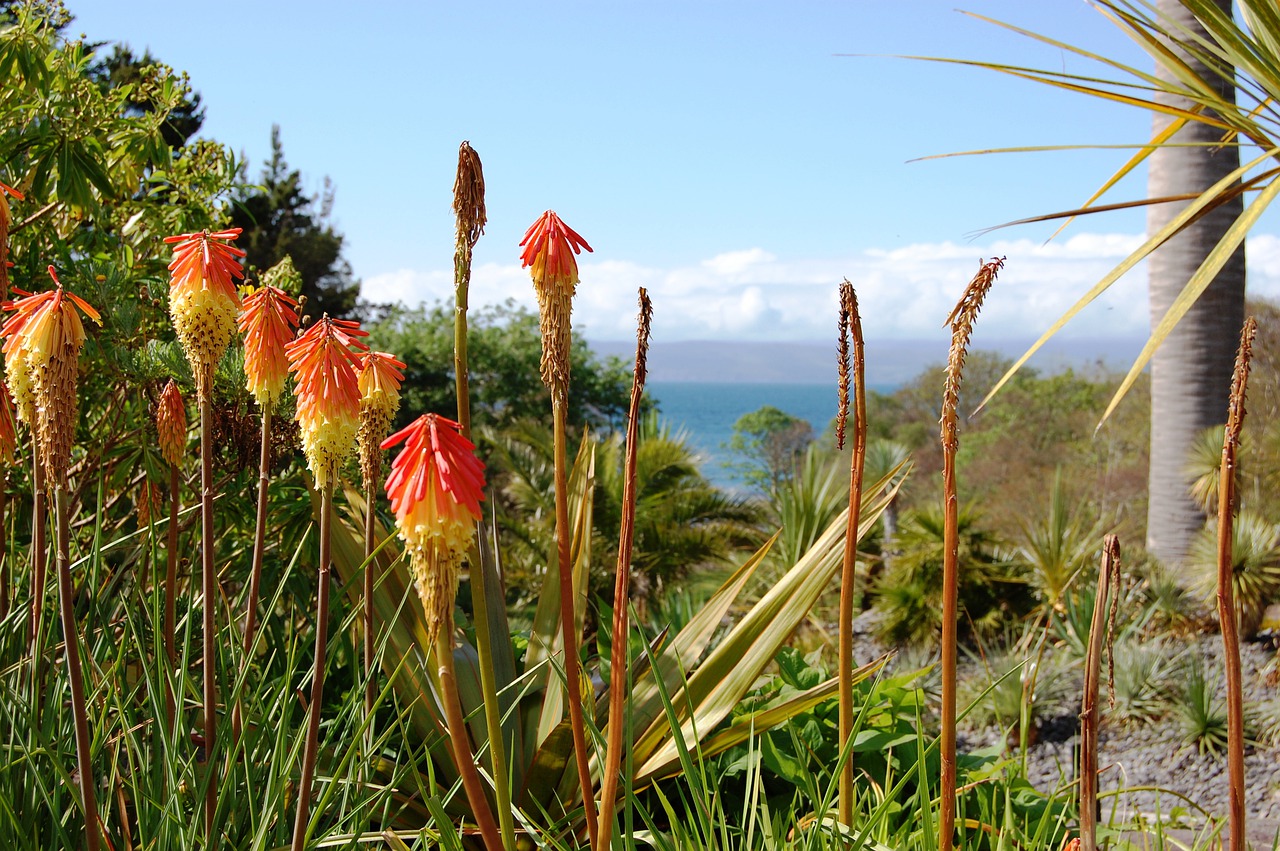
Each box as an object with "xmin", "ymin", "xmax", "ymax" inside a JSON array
[{"xmin": 856, "ymin": 606, "xmax": 1280, "ymax": 848}]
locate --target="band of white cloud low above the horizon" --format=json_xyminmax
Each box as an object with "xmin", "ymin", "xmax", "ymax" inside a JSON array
[{"xmin": 364, "ymin": 233, "xmax": 1280, "ymax": 342}]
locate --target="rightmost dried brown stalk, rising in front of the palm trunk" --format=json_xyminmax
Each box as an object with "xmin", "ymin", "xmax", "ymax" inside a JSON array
[{"xmin": 1217, "ymin": 316, "xmax": 1258, "ymax": 851}]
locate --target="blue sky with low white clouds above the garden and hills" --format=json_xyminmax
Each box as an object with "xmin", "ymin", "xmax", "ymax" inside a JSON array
[{"xmin": 70, "ymin": 0, "xmax": 1280, "ymax": 340}]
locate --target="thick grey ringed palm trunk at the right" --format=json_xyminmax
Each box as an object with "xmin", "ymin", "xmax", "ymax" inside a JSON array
[{"xmin": 1147, "ymin": 0, "xmax": 1244, "ymax": 568}]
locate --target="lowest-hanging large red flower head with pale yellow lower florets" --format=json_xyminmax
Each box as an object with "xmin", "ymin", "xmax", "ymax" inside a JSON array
[{"xmin": 381, "ymin": 413, "xmax": 484, "ymax": 639}]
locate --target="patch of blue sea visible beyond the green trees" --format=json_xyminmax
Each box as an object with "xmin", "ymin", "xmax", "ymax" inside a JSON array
[{"xmin": 648, "ymin": 381, "xmax": 855, "ymax": 488}]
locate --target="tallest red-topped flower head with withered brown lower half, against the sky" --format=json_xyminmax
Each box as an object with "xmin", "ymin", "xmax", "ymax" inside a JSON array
[{"xmin": 520, "ymin": 210, "xmax": 591, "ymax": 397}]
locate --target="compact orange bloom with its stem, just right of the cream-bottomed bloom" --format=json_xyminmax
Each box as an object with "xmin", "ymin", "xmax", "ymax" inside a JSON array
[{"xmin": 232, "ymin": 284, "xmax": 298, "ymax": 738}]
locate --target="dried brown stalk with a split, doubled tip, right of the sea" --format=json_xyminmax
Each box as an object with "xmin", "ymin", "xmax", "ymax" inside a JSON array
[{"xmin": 836, "ymin": 279, "xmax": 867, "ymax": 825}]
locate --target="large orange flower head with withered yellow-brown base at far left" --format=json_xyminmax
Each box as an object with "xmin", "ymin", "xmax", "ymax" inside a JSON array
[{"xmin": 0, "ymin": 266, "xmax": 101, "ymax": 488}]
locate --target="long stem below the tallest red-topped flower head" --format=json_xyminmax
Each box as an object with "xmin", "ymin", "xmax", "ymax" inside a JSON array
[{"xmin": 552, "ymin": 399, "xmax": 600, "ymax": 851}]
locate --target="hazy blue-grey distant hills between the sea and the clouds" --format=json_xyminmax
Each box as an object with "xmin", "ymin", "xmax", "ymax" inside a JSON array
[{"xmin": 591, "ymin": 338, "xmax": 1143, "ymax": 386}]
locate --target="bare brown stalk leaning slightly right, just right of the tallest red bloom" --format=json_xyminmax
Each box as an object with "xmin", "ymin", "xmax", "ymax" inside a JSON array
[{"xmin": 596, "ymin": 287, "xmax": 653, "ymax": 848}]
